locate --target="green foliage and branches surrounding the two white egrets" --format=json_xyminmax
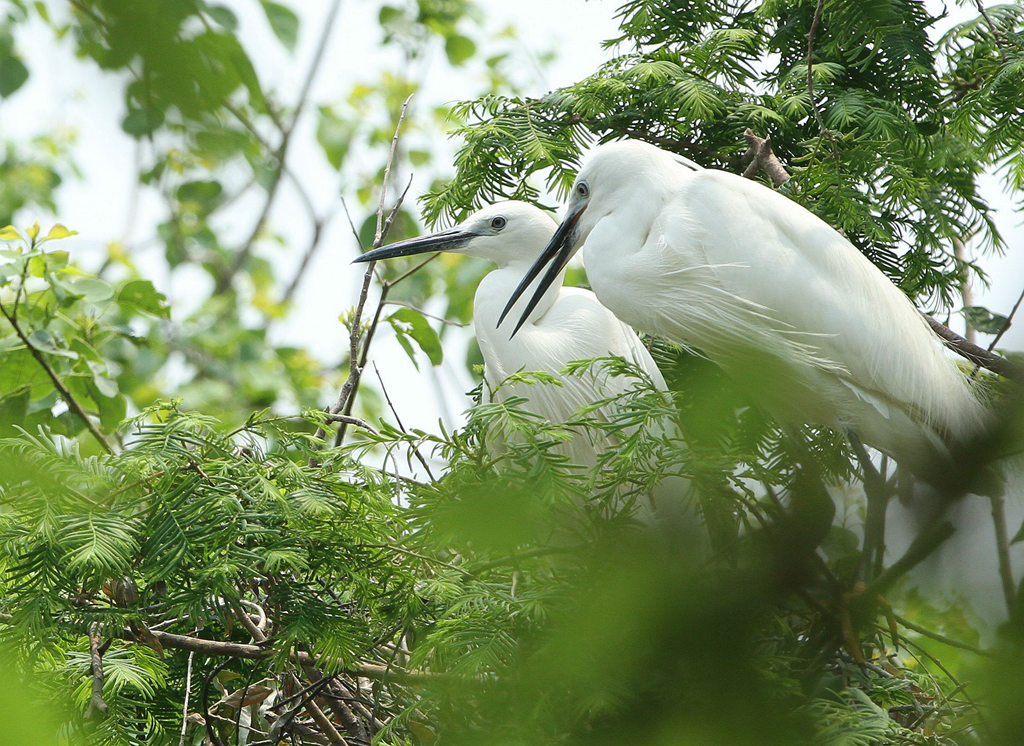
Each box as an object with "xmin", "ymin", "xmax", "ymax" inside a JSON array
[{"xmin": 0, "ymin": 0, "xmax": 1024, "ymax": 746}]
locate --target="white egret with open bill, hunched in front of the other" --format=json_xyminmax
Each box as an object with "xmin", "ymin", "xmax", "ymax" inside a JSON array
[{"xmin": 502, "ymin": 140, "xmax": 984, "ymax": 476}]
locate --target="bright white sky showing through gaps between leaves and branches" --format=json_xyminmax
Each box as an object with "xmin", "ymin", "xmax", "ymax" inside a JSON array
[{"xmin": 0, "ymin": 0, "xmax": 1024, "ymax": 430}]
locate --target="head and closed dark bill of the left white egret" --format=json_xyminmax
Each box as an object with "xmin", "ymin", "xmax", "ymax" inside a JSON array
[{"xmin": 355, "ymin": 200, "xmax": 555, "ymax": 267}]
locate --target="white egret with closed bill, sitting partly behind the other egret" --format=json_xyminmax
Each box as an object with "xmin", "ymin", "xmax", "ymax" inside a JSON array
[{"xmin": 355, "ymin": 202, "xmax": 667, "ymax": 468}]
